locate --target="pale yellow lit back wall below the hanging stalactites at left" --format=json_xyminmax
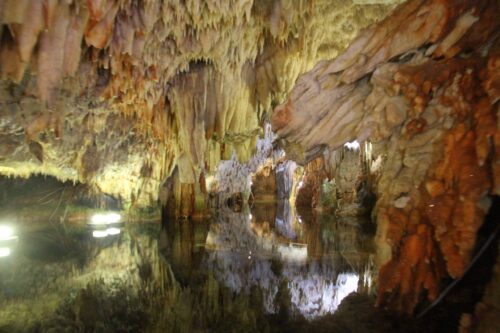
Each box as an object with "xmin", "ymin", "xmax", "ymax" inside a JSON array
[{"xmin": 0, "ymin": 80, "xmax": 171, "ymax": 205}]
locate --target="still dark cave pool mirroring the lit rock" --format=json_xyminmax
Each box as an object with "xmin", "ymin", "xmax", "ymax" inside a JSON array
[{"xmin": 0, "ymin": 204, "xmax": 373, "ymax": 332}]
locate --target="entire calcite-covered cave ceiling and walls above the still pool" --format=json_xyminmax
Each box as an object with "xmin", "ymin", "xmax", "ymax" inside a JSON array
[{"xmin": 0, "ymin": 0, "xmax": 500, "ymax": 313}]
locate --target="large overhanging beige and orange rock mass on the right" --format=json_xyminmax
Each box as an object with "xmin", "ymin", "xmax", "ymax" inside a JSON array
[{"xmin": 271, "ymin": 0, "xmax": 500, "ymax": 312}]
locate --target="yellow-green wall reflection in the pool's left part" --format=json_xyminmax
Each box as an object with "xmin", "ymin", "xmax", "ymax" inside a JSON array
[{"xmin": 0, "ymin": 225, "xmax": 163, "ymax": 332}]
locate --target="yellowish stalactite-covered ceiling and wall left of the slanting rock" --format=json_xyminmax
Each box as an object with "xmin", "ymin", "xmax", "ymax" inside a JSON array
[{"xmin": 0, "ymin": 0, "xmax": 400, "ymax": 206}]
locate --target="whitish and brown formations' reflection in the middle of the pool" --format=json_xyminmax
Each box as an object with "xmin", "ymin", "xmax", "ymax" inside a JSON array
[{"xmin": 203, "ymin": 202, "xmax": 371, "ymax": 319}]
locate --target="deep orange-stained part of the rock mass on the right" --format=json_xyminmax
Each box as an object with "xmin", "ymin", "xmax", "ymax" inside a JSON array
[{"xmin": 377, "ymin": 50, "xmax": 500, "ymax": 312}]
